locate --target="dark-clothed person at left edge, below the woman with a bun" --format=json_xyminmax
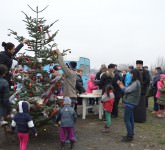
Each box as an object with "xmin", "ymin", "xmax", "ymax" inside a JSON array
[{"xmin": 0, "ymin": 64, "xmax": 10, "ymax": 126}]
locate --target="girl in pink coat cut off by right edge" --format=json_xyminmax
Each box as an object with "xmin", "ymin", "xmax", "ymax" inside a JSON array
[{"xmin": 156, "ymin": 74, "xmax": 165, "ymax": 117}]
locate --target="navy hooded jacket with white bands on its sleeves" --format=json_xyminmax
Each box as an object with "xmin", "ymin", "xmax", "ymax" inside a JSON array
[{"xmin": 11, "ymin": 101, "xmax": 36, "ymax": 133}]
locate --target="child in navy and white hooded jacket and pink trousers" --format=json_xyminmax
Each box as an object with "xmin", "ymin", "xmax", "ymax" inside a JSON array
[{"xmin": 11, "ymin": 101, "xmax": 37, "ymax": 150}]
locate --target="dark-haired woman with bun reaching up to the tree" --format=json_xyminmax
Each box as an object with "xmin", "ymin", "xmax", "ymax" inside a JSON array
[{"xmin": 0, "ymin": 39, "xmax": 28, "ymax": 85}]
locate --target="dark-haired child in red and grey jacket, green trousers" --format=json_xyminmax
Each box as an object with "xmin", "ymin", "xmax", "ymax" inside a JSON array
[{"xmin": 101, "ymin": 85, "xmax": 114, "ymax": 132}]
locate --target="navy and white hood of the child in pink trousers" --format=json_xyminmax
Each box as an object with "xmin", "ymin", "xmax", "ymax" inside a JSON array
[{"xmin": 18, "ymin": 101, "xmax": 30, "ymax": 113}]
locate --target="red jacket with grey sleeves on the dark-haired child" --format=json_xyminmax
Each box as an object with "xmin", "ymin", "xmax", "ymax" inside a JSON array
[{"xmin": 101, "ymin": 92, "xmax": 114, "ymax": 112}]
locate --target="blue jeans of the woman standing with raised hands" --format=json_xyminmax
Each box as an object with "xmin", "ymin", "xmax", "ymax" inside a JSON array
[{"xmin": 124, "ymin": 106, "xmax": 134, "ymax": 137}]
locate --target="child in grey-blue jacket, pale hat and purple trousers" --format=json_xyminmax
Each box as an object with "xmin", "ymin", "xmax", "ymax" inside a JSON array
[{"xmin": 57, "ymin": 97, "xmax": 77, "ymax": 150}]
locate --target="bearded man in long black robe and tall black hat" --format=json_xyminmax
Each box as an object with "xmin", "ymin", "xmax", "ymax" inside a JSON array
[{"xmin": 134, "ymin": 60, "xmax": 150, "ymax": 123}]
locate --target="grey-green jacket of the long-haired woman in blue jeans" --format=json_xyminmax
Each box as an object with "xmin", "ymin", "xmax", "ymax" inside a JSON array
[{"xmin": 122, "ymin": 80, "xmax": 141, "ymax": 106}]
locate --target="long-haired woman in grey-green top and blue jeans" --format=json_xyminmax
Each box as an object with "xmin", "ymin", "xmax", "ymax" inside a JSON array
[{"xmin": 117, "ymin": 70, "xmax": 141, "ymax": 142}]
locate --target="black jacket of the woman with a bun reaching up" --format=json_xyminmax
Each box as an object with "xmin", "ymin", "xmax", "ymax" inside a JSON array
[{"xmin": 0, "ymin": 43, "xmax": 23, "ymax": 83}]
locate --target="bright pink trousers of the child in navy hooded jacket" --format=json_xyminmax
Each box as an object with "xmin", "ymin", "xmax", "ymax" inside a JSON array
[{"xmin": 18, "ymin": 133, "xmax": 29, "ymax": 150}]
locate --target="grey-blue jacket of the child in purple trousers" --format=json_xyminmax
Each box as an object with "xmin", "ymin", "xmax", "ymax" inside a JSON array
[{"xmin": 57, "ymin": 106, "xmax": 77, "ymax": 127}]
